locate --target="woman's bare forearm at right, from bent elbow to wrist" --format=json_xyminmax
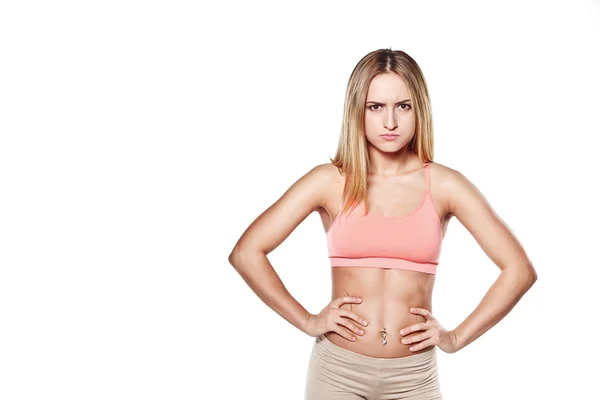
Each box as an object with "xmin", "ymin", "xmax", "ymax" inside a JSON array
[{"xmin": 454, "ymin": 268, "xmax": 536, "ymax": 351}]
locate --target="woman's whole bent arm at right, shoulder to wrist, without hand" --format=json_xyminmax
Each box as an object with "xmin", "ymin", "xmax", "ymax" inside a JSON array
[{"xmin": 443, "ymin": 168, "xmax": 537, "ymax": 351}]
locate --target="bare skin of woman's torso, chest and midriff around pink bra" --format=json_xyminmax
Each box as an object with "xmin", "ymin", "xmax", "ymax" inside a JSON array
[{"xmin": 318, "ymin": 162, "xmax": 451, "ymax": 358}]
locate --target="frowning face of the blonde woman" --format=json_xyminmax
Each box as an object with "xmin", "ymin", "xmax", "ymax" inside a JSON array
[{"xmin": 365, "ymin": 73, "xmax": 415, "ymax": 153}]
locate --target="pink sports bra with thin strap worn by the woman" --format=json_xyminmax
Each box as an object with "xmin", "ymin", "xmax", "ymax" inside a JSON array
[{"xmin": 327, "ymin": 163, "xmax": 442, "ymax": 274}]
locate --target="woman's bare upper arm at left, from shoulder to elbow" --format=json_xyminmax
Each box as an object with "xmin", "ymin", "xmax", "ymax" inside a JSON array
[{"xmin": 232, "ymin": 164, "xmax": 337, "ymax": 254}]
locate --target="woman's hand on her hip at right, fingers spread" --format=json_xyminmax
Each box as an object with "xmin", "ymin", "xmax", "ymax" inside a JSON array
[{"xmin": 400, "ymin": 307, "xmax": 458, "ymax": 353}]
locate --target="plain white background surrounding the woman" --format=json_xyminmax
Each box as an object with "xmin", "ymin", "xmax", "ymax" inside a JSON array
[{"xmin": 0, "ymin": 0, "xmax": 600, "ymax": 400}]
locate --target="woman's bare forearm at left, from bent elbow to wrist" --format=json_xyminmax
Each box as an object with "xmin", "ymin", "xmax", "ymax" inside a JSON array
[{"xmin": 229, "ymin": 251, "xmax": 310, "ymax": 332}]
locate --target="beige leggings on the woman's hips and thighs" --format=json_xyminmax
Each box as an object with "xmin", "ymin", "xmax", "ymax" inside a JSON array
[{"xmin": 305, "ymin": 335, "xmax": 442, "ymax": 400}]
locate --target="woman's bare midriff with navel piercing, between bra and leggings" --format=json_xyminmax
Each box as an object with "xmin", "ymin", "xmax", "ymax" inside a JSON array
[{"xmin": 325, "ymin": 267, "xmax": 435, "ymax": 358}]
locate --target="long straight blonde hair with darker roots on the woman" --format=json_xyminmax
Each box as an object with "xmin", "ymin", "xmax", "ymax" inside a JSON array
[{"xmin": 329, "ymin": 48, "xmax": 433, "ymax": 220}]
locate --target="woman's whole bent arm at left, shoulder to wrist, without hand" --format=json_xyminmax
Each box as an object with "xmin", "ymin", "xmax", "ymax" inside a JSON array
[{"xmin": 229, "ymin": 164, "xmax": 336, "ymax": 333}]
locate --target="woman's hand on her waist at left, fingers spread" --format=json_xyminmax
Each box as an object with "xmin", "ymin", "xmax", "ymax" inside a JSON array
[{"xmin": 304, "ymin": 296, "xmax": 368, "ymax": 342}]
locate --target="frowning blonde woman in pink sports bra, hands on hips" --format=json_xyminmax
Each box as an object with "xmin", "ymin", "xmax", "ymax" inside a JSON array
[{"xmin": 229, "ymin": 49, "xmax": 537, "ymax": 400}]
